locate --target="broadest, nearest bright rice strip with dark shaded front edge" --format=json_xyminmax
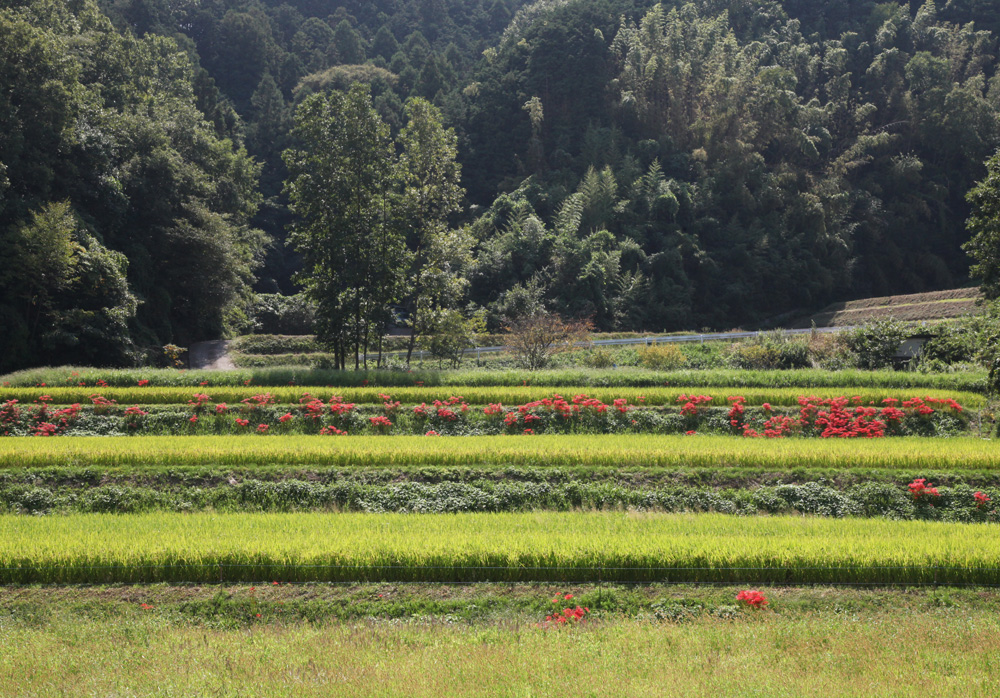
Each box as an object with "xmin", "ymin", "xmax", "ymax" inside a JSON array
[{"xmin": 0, "ymin": 512, "xmax": 1000, "ymax": 585}]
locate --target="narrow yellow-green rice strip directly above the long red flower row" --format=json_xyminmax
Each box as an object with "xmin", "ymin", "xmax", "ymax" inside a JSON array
[{"xmin": 0, "ymin": 385, "xmax": 985, "ymax": 408}]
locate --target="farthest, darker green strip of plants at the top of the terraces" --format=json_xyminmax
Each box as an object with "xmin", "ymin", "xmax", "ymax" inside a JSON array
[{"xmin": 0, "ymin": 366, "xmax": 987, "ymax": 393}]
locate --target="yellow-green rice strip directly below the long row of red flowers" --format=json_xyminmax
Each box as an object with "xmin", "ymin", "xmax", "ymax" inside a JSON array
[{"xmin": 0, "ymin": 434, "xmax": 1000, "ymax": 471}]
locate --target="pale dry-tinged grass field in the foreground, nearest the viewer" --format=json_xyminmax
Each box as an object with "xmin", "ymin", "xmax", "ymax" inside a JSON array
[{"xmin": 0, "ymin": 610, "xmax": 1000, "ymax": 698}]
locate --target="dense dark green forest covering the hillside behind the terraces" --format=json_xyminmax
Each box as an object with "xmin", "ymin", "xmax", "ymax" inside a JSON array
[{"xmin": 0, "ymin": 0, "xmax": 1000, "ymax": 369}]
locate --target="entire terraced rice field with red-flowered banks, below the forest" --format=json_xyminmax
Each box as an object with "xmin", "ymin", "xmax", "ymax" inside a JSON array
[{"xmin": 0, "ymin": 368, "xmax": 1000, "ymax": 696}]
